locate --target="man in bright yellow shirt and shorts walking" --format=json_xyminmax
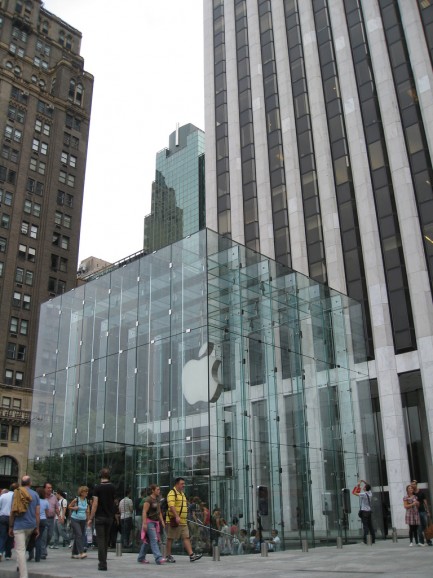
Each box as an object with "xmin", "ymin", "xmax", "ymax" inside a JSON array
[{"xmin": 165, "ymin": 478, "xmax": 203, "ymax": 563}]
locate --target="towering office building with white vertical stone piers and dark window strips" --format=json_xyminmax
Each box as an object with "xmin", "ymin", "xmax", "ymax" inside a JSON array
[{"xmin": 204, "ymin": 0, "xmax": 433, "ymax": 527}]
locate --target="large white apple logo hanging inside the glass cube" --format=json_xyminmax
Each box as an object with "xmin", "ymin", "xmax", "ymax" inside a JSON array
[{"xmin": 182, "ymin": 343, "xmax": 223, "ymax": 405}]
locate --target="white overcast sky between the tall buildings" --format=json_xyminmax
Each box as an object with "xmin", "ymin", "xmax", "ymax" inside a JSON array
[{"xmin": 44, "ymin": 0, "xmax": 204, "ymax": 262}]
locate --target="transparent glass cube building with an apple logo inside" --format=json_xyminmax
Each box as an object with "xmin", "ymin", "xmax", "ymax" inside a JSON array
[{"xmin": 30, "ymin": 229, "xmax": 382, "ymax": 547}]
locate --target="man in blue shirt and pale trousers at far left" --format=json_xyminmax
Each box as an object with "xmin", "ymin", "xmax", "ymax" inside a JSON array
[{"xmin": 9, "ymin": 476, "xmax": 40, "ymax": 578}]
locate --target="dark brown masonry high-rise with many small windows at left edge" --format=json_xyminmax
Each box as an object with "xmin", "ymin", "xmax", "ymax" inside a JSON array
[{"xmin": 0, "ymin": 0, "xmax": 93, "ymax": 485}]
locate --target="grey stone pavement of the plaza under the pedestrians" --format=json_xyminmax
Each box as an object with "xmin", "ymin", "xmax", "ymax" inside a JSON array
[{"xmin": 0, "ymin": 538, "xmax": 433, "ymax": 578}]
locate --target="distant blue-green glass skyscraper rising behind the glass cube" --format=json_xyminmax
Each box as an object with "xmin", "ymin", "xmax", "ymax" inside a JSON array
[{"xmin": 144, "ymin": 124, "xmax": 205, "ymax": 253}]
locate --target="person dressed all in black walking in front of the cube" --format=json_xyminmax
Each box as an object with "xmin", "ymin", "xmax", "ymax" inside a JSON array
[{"xmin": 87, "ymin": 468, "xmax": 116, "ymax": 571}]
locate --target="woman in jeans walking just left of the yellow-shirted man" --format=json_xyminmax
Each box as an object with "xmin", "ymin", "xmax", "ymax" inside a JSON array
[{"xmin": 137, "ymin": 484, "xmax": 166, "ymax": 565}]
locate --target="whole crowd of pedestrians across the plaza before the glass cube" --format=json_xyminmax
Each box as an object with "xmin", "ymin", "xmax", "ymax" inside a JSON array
[{"xmin": 0, "ymin": 468, "xmax": 433, "ymax": 578}]
